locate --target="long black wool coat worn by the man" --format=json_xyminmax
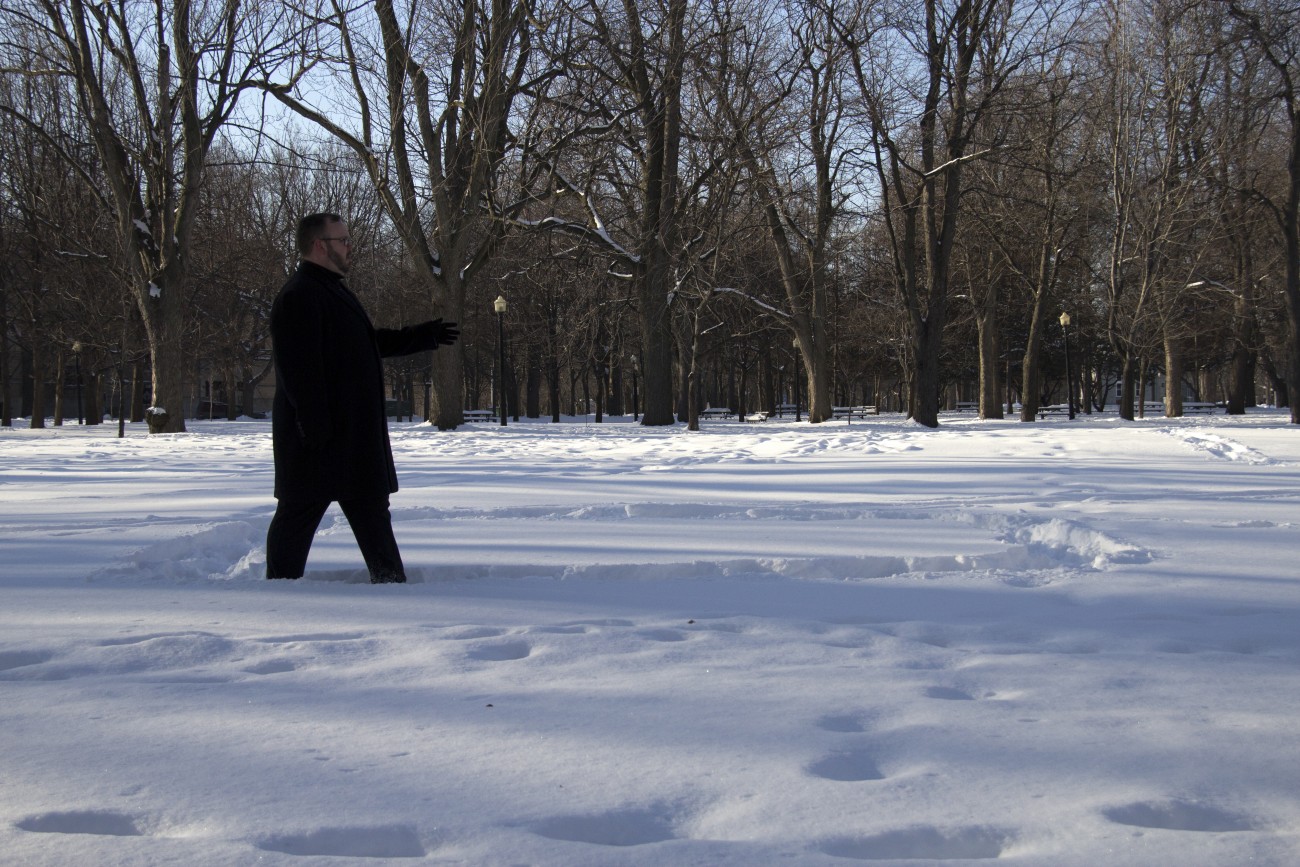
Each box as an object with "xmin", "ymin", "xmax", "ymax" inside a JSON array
[{"xmin": 270, "ymin": 261, "xmax": 437, "ymax": 500}]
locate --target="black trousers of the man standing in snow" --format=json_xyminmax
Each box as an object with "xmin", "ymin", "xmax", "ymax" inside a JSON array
[{"xmin": 267, "ymin": 495, "xmax": 406, "ymax": 581}]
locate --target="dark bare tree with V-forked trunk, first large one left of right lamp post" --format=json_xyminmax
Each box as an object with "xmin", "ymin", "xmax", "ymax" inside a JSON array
[{"xmin": 844, "ymin": 0, "xmax": 1057, "ymax": 426}]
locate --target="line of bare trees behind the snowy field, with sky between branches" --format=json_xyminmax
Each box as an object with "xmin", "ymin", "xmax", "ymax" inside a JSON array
[{"xmin": 0, "ymin": 0, "xmax": 1300, "ymax": 432}]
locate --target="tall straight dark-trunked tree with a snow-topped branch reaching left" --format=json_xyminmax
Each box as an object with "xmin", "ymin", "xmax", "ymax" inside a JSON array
[{"xmin": 512, "ymin": 0, "xmax": 692, "ymax": 425}]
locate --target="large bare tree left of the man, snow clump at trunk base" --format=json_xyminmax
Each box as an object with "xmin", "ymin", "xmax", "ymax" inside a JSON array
[{"xmin": 0, "ymin": 0, "xmax": 292, "ymax": 432}]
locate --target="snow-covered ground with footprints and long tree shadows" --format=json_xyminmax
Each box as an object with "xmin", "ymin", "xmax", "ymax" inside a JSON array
[{"xmin": 0, "ymin": 411, "xmax": 1300, "ymax": 867}]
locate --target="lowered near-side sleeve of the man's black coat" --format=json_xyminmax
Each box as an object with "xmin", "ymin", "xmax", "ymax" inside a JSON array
[{"xmin": 270, "ymin": 291, "xmax": 332, "ymax": 448}]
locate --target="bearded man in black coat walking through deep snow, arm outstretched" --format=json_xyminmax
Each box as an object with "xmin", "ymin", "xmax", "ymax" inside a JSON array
[{"xmin": 267, "ymin": 213, "xmax": 460, "ymax": 584}]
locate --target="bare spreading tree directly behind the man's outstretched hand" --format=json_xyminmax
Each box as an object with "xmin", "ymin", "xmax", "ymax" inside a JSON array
[{"xmin": 264, "ymin": 0, "xmax": 553, "ymax": 429}]
